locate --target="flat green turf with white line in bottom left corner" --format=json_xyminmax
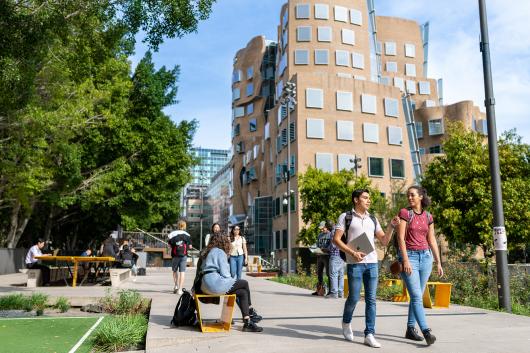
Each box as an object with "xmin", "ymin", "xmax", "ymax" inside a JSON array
[{"xmin": 0, "ymin": 317, "xmax": 101, "ymax": 353}]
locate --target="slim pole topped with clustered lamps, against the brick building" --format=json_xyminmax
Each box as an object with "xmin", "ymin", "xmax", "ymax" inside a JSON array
[{"xmin": 280, "ymin": 81, "xmax": 296, "ymax": 273}]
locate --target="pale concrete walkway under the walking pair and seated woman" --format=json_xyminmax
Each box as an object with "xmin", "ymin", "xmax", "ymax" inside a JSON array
[{"xmin": 0, "ymin": 269, "xmax": 530, "ymax": 353}]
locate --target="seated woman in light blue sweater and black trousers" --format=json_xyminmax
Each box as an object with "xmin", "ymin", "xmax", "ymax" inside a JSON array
[{"xmin": 201, "ymin": 233, "xmax": 263, "ymax": 332}]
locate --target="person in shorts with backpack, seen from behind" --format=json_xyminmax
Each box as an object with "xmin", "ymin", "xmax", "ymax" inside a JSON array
[{"xmin": 168, "ymin": 220, "xmax": 192, "ymax": 295}]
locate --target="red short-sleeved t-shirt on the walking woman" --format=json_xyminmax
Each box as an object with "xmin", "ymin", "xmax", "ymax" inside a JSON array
[{"xmin": 399, "ymin": 208, "xmax": 434, "ymax": 250}]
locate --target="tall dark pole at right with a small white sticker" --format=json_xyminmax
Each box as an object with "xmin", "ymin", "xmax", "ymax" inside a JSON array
[{"xmin": 478, "ymin": 0, "xmax": 512, "ymax": 313}]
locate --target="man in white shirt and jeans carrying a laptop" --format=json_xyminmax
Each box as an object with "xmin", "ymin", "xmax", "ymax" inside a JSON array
[{"xmin": 333, "ymin": 189, "xmax": 399, "ymax": 348}]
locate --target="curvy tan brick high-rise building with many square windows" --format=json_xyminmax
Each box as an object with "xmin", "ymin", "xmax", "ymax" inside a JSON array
[{"xmin": 230, "ymin": 0, "xmax": 485, "ymax": 266}]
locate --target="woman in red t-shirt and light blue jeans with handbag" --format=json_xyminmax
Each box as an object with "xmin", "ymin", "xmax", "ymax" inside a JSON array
[{"xmin": 398, "ymin": 186, "xmax": 443, "ymax": 345}]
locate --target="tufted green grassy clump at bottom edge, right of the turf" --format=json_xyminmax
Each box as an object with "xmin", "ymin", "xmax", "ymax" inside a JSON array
[{"xmin": 93, "ymin": 315, "xmax": 147, "ymax": 352}]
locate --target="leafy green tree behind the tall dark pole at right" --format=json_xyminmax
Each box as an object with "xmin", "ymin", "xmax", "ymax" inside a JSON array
[{"xmin": 416, "ymin": 123, "xmax": 530, "ymax": 255}]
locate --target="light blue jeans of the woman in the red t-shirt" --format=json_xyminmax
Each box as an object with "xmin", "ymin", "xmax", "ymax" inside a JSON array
[{"xmin": 399, "ymin": 250, "xmax": 432, "ymax": 331}]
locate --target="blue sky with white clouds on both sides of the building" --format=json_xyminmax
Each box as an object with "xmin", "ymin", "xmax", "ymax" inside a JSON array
[{"xmin": 131, "ymin": 0, "xmax": 530, "ymax": 149}]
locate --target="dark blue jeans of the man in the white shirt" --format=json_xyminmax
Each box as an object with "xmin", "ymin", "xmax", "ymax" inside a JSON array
[{"xmin": 342, "ymin": 264, "xmax": 379, "ymax": 336}]
